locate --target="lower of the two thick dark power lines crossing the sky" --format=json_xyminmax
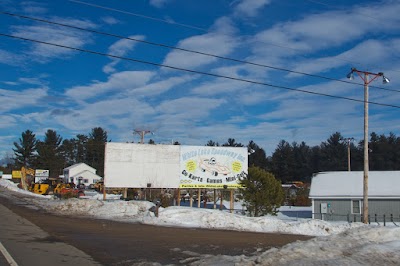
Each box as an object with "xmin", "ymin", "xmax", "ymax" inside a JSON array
[{"xmin": 0, "ymin": 33, "xmax": 400, "ymax": 109}]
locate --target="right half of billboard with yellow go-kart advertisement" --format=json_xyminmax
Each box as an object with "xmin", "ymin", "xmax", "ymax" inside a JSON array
[{"xmin": 179, "ymin": 146, "xmax": 248, "ymax": 188}]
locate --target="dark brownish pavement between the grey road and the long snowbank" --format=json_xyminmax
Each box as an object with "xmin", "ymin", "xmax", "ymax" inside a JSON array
[{"xmin": 0, "ymin": 191, "xmax": 310, "ymax": 265}]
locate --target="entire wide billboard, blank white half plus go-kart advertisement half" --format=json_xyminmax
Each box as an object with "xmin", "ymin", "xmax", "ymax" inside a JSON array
[{"xmin": 104, "ymin": 142, "xmax": 248, "ymax": 188}]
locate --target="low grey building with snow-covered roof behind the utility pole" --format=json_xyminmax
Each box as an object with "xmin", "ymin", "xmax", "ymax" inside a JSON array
[{"xmin": 309, "ymin": 171, "xmax": 400, "ymax": 223}]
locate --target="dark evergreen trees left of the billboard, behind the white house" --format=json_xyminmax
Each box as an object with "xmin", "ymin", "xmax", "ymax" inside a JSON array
[{"xmin": 7, "ymin": 127, "xmax": 108, "ymax": 177}]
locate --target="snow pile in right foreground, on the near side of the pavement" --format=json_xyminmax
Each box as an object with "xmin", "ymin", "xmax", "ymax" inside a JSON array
[{"xmin": 188, "ymin": 226, "xmax": 400, "ymax": 266}]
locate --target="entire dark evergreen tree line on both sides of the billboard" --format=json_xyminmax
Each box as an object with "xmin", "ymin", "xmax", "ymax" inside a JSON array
[{"xmin": 3, "ymin": 127, "xmax": 400, "ymax": 183}]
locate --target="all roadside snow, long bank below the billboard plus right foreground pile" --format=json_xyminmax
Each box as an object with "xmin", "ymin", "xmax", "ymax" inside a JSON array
[{"xmin": 0, "ymin": 179, "xmax": 400, "ymax": 266}]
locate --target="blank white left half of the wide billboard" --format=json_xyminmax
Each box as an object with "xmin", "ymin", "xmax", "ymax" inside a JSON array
[{"xmin": 104, "ymin": 142, "xmax": 180, "ymax": 188}]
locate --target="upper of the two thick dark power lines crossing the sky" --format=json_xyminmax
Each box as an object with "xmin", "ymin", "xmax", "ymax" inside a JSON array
[{"xmin": 0, "ymin": 11, "xmax": 400, "ymax": 92}]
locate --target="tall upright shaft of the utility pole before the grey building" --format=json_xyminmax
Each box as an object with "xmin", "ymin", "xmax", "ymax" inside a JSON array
[{"xmin": 363, "ymin": 73, "xmax": 369, "ymax": 224}]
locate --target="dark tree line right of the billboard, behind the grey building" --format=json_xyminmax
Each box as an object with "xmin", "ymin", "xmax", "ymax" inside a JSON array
[{"xmin": 207, "ymin": 132, "xmax": 400, "ymax": 183}]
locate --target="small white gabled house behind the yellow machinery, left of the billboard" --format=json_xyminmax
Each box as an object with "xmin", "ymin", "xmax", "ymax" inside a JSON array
[{"xmin": 64, "ymin": 163, "xmax": 102, "ymax": 187}]
